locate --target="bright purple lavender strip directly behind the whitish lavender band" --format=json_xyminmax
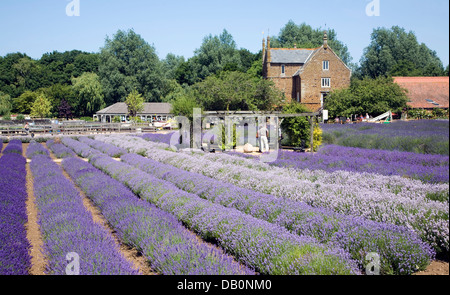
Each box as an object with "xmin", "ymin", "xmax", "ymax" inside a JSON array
[{"xmin": 270, "ymin": 145, "xmax": 449, "ymax": 183}]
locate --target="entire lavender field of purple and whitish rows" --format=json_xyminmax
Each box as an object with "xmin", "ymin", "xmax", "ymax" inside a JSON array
[{"xmin": 0, "ymin": 122, "xmax": 449, "ymax": 275}]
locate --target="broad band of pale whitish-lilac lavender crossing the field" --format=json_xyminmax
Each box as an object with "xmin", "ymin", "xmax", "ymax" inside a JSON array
[{"xmin": 93, "ymin": 136, "xmax": 449, "ymax": 255}]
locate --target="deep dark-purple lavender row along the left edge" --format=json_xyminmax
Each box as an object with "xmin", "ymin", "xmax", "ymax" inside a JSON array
[{"xmin": 0, "ymin": 153, "xmax": 31, "ymax": 275}]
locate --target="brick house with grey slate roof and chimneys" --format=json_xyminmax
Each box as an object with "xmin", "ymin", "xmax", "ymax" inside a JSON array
[{"xmin": 263, "ymin": 32, "xmax": 352, "ymax": 111}]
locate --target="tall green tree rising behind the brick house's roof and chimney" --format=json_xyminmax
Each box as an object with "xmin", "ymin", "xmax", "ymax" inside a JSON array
[{"xmin": 271, "ymin": 20, "xmax": 352, "ymax": 66}]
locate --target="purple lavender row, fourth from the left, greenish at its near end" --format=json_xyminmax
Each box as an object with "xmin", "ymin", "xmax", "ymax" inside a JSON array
[{"xmin": 91, "ymin": 156, "xmax": 359, "ymax": 275}]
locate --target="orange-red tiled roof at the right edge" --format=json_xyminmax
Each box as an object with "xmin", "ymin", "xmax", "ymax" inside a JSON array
[{"xmin": 394, "ymin": 77, "xmax": 449, "ymax": 109}]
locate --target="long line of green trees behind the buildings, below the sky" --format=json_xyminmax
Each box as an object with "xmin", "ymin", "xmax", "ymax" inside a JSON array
[{"xmin": 0, "ymin": 21, "xmax": 448, "ymax": 119}]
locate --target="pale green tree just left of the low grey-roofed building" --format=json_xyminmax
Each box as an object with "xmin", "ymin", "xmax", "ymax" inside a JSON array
[{"xmin": 72, "ymin": 73, "xmax": 105, "ymax": 117}]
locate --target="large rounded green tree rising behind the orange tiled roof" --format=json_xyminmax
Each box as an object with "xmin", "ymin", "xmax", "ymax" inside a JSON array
[{"xmin": 360, "ymin": 26, "xmax": 444, "ymax": 78}]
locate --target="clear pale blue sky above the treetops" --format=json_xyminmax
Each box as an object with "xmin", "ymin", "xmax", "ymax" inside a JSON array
[{"xmin": 0, "ymin": 0, "xmax": 449, "ymax": 66}]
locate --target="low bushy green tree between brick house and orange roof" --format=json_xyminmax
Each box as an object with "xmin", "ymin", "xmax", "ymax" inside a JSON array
[{"xmin": 325, "ymin": 77, "xmax": 408, "ymax": 118}]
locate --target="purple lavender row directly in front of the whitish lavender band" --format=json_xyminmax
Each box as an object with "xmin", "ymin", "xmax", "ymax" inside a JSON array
[{"xmin": 121, "ymin": 154, "xmax": 433, "ymax": 274}]
